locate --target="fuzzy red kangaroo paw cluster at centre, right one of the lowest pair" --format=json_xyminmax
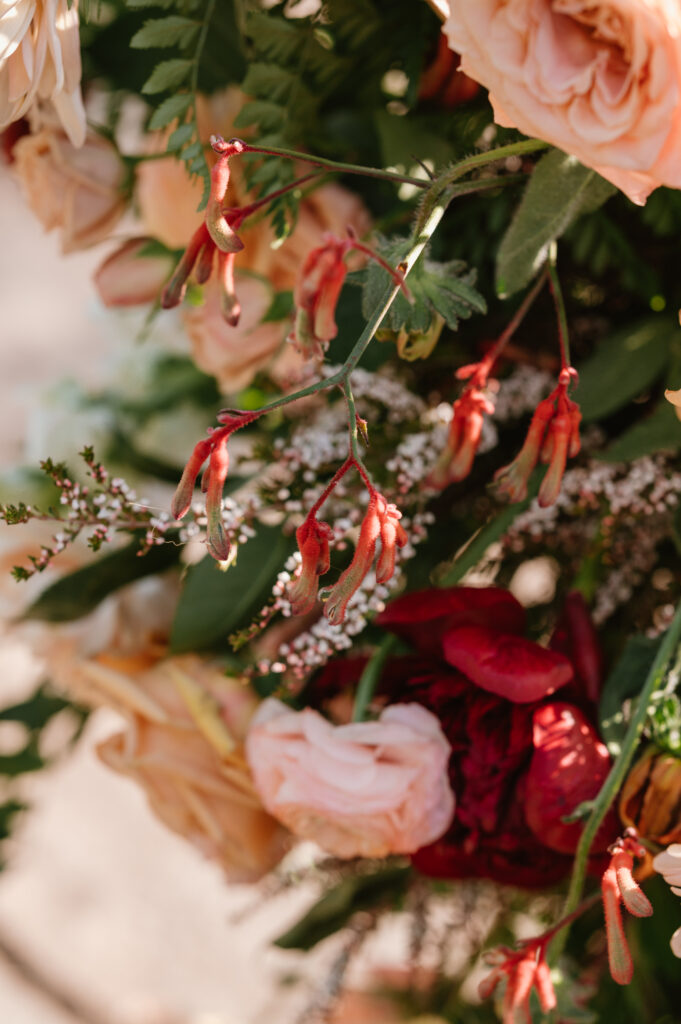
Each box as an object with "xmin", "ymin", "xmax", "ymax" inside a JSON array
[{"xmin": 321, "ymin": 490, "xmax": 408, "ymax": 626}]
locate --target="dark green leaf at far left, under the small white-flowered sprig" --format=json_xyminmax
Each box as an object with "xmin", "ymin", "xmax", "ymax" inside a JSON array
[{"xmin": 22, "ymin": 542, "xmax": 179, "ymax": 623}]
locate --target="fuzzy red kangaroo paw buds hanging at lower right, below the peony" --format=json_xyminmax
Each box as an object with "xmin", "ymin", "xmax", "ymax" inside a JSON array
[{"xmin": 601, "ymin": 828, "xmax": 652, "ymax": 985}]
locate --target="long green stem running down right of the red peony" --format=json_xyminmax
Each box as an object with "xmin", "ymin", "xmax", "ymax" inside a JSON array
[{"xmin": 553, "ymin": 602, "xmax": 681, "ymax": 957}]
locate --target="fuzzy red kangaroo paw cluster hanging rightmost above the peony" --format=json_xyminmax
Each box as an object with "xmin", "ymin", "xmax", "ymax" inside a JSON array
[{"xmin": 495, "ymin": 367, "xmax": 582, "ymax": 508}]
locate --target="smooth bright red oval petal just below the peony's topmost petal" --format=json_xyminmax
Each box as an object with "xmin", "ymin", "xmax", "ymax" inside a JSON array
[{"xmin": 442, "ymin": 626, "xmax": 572, "ymax": 703}]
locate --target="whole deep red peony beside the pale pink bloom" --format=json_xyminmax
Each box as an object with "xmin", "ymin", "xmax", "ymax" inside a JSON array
[{"xmin": 318, "ymin": 587, "xmax": 616, "ymax": 888}]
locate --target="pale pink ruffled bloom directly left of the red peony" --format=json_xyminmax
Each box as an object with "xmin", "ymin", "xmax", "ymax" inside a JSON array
[{"xmin": 241, "ymin": 698, "xmax": 454, "ymax": 857}]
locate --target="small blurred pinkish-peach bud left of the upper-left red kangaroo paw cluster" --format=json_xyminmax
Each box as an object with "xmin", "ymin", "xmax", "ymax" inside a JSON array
[{"xmin": 93, "ymin": 239, "xmax": 175, "ymax": 307}]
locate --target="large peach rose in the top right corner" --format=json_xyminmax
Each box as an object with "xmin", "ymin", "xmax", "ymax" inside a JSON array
[{"xmin": 443, "ymin": 0, "xmax": 681, "ymax": 205}]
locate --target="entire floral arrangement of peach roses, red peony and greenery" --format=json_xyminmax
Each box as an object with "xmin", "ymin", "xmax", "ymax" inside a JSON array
[{"xmin": 5, "ymin": 0, "xmax": 681, "ymax": 1024}]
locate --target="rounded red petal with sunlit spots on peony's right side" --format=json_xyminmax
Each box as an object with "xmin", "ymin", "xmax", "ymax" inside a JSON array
[{"xmin": 525, "ymin": 702, "xmax": 616, "ymax": 853}]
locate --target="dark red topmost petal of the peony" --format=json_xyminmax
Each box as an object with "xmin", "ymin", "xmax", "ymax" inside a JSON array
[{"xmin": 378, "ymin": 587, "xmax": 525, "ymax": 656}]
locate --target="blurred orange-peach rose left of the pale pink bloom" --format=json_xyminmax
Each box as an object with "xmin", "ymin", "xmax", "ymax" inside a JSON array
[{"xmin": 69, "ymin": 654, "xmax": 287, "ymax": 882}]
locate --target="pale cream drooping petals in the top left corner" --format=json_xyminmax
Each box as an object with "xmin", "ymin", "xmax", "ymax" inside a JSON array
[{"xmin": 0, "ymin": 0, "xmax": 86, "ymax": 146}]
